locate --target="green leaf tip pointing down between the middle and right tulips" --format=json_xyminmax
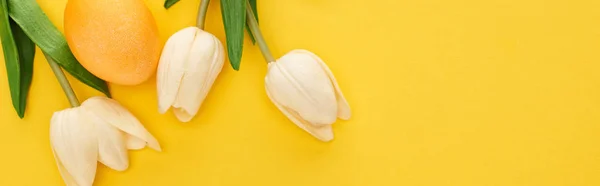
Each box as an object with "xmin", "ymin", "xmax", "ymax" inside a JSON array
[{"xmin": 221, "ymin": 0, "xmax": 246, "ymax": 70}]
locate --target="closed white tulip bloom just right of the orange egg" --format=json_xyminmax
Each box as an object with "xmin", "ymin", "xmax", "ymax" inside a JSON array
[{"xmin": 157, "ymin": 27, "xmax": 225, "ymax": 122}]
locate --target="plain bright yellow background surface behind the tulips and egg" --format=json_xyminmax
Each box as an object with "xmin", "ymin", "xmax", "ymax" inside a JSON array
[{"xmin": 0, "ymin": 0, "xmax": 600, "ymax": 186}]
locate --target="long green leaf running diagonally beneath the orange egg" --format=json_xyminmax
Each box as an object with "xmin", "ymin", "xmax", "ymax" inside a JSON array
[{"xmin": 8, "ymin": 0, "xmax": 110, "ymax": 97}]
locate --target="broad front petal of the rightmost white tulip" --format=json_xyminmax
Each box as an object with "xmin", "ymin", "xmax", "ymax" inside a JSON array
[{"xmin": 265, "ymin": 59, "xmax": 338, "ymax": 126}]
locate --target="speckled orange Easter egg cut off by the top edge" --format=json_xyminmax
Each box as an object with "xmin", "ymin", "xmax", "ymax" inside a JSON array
[{"xmin": 64, "ymin": 0, "xmax": 162, "ymax": 85}]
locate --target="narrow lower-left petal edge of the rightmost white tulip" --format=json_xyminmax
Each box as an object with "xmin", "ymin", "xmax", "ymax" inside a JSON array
[{"xmin": 266, "ymin": 86, "xmax": 333, "ymax": 142}]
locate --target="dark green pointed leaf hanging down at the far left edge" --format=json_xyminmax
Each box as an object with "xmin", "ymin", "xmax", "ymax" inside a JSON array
[{"xmin": 0, "ymin": 0, "xmax": 35, "ymax": 118}]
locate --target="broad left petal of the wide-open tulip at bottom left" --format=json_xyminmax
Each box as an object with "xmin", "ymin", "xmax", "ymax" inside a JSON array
[{"xmin": 50, "ymin": 108, "xmax": 98, "ymax": 186}]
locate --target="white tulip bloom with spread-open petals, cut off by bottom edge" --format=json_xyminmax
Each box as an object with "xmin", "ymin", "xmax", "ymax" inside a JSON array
[{"xmin": 50, "ymin": 97, "xmax": 161, "ymax": 186}]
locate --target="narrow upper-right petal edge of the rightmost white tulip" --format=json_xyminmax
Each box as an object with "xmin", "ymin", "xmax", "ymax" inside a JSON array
[{"xmin": 292, "ymin": 49, "xmax": 352, "ymax": 120}]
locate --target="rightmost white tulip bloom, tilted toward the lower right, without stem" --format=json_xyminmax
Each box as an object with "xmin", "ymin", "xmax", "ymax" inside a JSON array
[{"xmin": 265, "ymin": 50, "xmax": 351, "ymax": 141}]
